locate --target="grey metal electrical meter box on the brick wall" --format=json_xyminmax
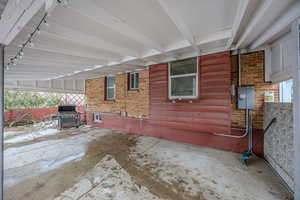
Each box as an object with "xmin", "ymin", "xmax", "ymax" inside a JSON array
[{"xmin": 238, "ymin": 87, "xmax": 255, "ymax": 110}]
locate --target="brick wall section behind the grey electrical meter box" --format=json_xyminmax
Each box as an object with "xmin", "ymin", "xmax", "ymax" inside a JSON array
[{"xmin": 231, "ymin": 51, "xmax": 279, "ymax": 129}]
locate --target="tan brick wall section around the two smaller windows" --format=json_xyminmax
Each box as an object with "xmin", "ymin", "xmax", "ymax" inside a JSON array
[{"xmin": 85, "ymin": 70, "xmax": 149, "ymax": 117}]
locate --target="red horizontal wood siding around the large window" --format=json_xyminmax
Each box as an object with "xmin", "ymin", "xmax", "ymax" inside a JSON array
[{"xmin": 149, "ymin": 52, "xmax": 231, "ymax": 133}]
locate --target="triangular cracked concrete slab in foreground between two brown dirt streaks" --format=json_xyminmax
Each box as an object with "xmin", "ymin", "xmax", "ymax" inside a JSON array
[{"xmin": 55, "ymin": 155, "xmax": 159, "ymax": 200}]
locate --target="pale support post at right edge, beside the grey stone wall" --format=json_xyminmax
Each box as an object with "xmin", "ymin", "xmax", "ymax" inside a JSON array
[{"xmin": 293, "ymin": 20, "xmax": 300, "ymax": 200}]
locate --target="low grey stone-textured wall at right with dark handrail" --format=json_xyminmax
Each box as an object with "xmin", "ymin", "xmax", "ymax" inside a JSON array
[{"xmin": 264, "ymin": 103, "xmax": 294, "ymax": 189}]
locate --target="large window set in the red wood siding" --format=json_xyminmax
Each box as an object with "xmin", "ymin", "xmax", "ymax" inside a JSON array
[{"xmin": 169, "ymin": 58, "xmax": 198, "ymax": 99}]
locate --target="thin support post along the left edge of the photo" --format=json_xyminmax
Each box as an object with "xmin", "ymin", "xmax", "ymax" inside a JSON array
[{"xmin": 0, "ymin": 44, "xmax": 4, "ymax": 200}]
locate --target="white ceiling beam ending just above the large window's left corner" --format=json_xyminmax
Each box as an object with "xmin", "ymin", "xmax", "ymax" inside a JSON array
[{"xmin": 67, "ymin": 0, "xmax": 163, "ymax": 52}]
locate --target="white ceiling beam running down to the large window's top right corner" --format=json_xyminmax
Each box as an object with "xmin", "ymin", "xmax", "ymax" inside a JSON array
[{"xmin": 157, "ymin": 0, "xmax": 200, "ymax": 54}]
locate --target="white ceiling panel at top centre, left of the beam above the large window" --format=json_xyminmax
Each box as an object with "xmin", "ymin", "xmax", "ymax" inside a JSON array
[{"xmin": 94, "ymin": 0, "xmax": 182, "ymax": 46}]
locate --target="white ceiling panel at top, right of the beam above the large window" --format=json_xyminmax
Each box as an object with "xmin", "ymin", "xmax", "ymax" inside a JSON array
[{"xmin": 157, "ymin": 0, "xmax": 239, "ymax": 40}]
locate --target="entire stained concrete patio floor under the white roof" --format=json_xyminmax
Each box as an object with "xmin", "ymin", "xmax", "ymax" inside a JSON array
[{"xmin": 4, "ymin": 126, "xmax": 290, "ymax": 200}]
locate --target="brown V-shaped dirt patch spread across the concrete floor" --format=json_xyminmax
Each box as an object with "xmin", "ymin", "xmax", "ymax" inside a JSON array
[{"xmin": 5, "ymin": 132, "xmax": 204, "ymax": 200}]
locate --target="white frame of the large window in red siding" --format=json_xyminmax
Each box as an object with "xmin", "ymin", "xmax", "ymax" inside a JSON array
[{"xmin": 168, "ymin": 57, "xmax": 199, "ymax": 100}]
